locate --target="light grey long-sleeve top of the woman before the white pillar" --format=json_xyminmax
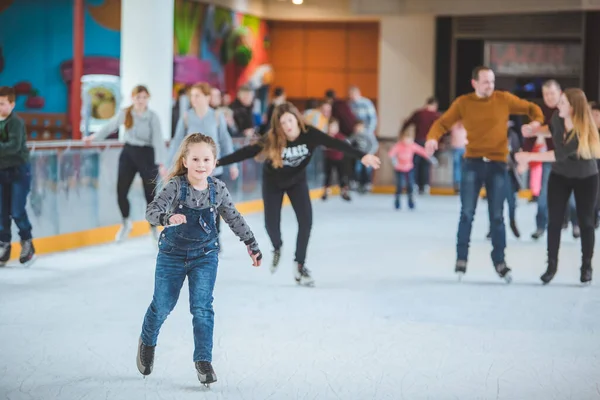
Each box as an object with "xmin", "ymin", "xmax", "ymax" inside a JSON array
[{"xmin": 94, "ymin": 108, "xmax": 167, "ymax": 166}]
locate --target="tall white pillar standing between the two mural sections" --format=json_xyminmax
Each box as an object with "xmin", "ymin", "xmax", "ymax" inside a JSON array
[{"xmin": 121, "ymin": 0, "xmax": 175, "ymax": 138}]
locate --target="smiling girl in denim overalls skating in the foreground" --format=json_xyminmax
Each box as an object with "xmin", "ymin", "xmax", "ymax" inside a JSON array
[{"xmin": 137, "ymin": 133, "xmax": 262, "ymax": 386}]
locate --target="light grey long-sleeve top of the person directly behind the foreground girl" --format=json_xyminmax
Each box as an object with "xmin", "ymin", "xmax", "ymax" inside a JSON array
[{"xmin": 169, "ymin": 108, "xmax": 233, "ymax": 176}]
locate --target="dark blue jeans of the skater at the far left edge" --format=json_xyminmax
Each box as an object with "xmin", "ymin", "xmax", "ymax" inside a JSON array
[{"xmin": 0, "ymin": 164, "xmax": 31, "ymax": 243}]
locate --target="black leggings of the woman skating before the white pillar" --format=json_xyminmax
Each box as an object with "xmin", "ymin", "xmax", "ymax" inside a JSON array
[{"xmin": 117, "ymin": 144, "xmax": 158, "ymax": 218}]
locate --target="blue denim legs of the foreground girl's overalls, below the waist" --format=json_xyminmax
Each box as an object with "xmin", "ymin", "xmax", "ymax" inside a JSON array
[{"xmin": 141, "ymin": 241, "xmax": 219, "ymax": 361}]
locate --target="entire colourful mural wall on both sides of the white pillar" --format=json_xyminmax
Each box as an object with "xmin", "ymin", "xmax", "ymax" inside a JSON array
[{"xmin": 0, "ymin": 0, "xmax": 272, "ymax": 113}]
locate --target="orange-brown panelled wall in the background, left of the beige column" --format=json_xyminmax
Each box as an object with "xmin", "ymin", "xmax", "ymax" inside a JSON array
[{"xmin": 269, "ymin": 21, "xmax": 379, "ymax": 101}]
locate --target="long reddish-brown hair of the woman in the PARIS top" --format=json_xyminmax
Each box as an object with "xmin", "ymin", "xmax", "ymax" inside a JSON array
[{"xmin": 258, "ymin": 102, "xmax": 306, "ymax": 168}]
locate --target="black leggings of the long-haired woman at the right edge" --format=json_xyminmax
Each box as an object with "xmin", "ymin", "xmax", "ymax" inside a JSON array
[{"xmin": 548, "ymin": 172, "xmax": 598, "ymax": 262}]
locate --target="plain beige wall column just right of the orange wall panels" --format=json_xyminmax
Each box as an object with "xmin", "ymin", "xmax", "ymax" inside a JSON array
[{"xmin": 377, "ymin": 15, "xmax": 435, "ymax": 137}]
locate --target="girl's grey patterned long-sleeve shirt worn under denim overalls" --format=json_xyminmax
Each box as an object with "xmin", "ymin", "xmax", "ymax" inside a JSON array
[{"xmin": 146, "ymin": 176, "xmax": 258, "ymax": 250}]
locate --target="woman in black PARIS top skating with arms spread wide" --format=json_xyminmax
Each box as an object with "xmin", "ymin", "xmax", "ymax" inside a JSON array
[{"xmin": 219, "ymin": 103, "xmax": 380, "ymax": 285}]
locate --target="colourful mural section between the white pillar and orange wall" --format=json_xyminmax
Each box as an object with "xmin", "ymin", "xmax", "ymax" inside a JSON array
[{"xmin": 173, "ymin": 0, "xmax": 273, "ymax": 98}]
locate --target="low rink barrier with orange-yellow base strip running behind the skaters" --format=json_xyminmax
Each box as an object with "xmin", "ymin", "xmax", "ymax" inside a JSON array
[{"xmin": 11, "ymin": 139, "xmax": 530, "ymax": 258}]
